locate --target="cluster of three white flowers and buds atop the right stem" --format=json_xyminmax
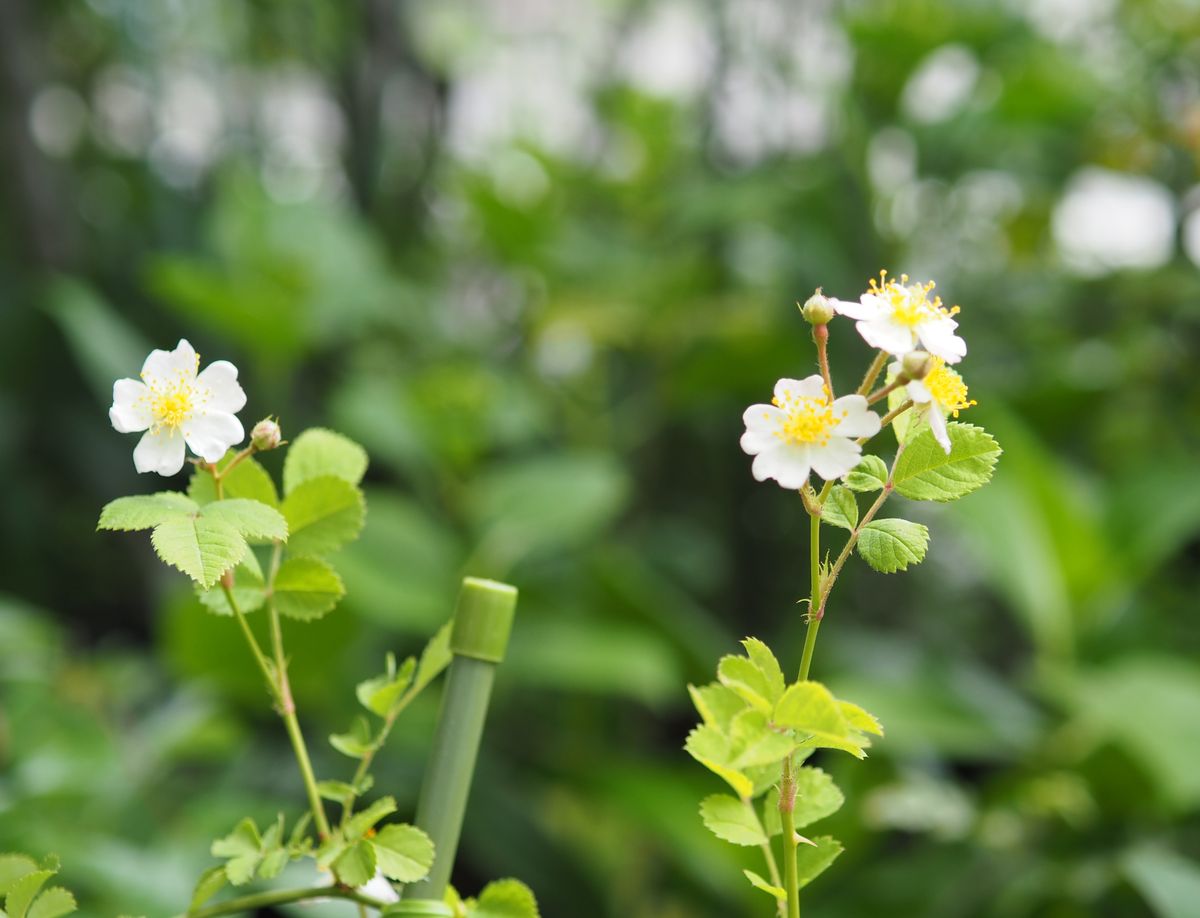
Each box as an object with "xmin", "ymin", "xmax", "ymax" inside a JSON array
[{"xmin": 742, "ymin": 271, "xmax": 974, "ymax": 490}]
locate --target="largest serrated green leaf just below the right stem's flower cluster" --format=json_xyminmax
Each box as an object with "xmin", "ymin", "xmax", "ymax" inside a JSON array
[{"xmin": 893, "ymin": 422, "xmax": 1001, "ymax": 500}]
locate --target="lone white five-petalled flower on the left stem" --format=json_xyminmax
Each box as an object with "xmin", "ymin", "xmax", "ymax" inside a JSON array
[{"xmin": 108, "ymin": 340, "xmax": 246, "ymax": 475}]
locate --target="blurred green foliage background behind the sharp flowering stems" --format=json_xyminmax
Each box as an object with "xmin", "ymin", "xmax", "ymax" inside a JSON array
[{"xmin": 0, "ymin": 0, "xmax": 1200, "ymax": 918}]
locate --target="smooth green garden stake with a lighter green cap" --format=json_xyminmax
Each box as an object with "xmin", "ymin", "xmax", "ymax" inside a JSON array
[{"xmin": 404, "ymin": 577, "xmax": 517, "ymax": 900}]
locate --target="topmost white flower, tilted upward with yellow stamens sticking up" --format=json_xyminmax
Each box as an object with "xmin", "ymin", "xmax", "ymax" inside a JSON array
[{"xmin": 833, "ymin": 271, "xmax": 967, "ymax": 364}]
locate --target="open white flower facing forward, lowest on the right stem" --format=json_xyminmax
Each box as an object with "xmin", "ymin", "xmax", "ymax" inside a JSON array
[{"xmin": 742, "ymin": 376, "xmax": 880, "ymax": 491}]
